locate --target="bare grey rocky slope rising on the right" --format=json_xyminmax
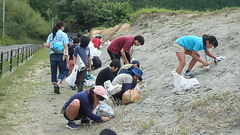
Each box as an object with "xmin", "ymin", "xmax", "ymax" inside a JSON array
[{"xmin": 92, "ymin": 10, "xmax": 240, "ymax": 134}]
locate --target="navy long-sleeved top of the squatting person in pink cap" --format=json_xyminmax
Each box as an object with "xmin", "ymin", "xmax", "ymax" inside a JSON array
[{"xmin": 64, "ymin": 90, "xmax": 102, "ymax": 122}]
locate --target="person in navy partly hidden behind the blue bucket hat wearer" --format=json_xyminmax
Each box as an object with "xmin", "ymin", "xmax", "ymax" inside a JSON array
[{"xmin": 117, "ymin": 60, "xmax": 140, "ymax": 75}]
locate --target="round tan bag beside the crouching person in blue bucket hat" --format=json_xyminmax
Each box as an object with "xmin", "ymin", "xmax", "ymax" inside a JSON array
[{"xmin": 122, "ymin": 89, "xmax": 140, "ymax": 104}]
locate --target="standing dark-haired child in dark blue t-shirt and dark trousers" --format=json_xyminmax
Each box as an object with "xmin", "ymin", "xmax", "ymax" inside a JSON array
[{"xmin": 73, "ymin": 36, "xmax": 91, "ymax": 92}]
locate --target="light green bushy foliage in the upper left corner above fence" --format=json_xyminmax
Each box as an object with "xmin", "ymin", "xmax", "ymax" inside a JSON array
[{"xmin": 0, "ymin": 0, "xmax": 50, "ymax": 45}]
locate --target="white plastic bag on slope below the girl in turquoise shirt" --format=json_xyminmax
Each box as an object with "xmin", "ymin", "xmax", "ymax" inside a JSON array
[{"xmin": 172, "ymin": 71, "xmax": 199, "ymax": 91}]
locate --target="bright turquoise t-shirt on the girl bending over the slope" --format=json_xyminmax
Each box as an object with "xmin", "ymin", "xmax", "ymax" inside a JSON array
[{"xmin": 176, "ymin": 36, "xmax": 207, "ymax": 52}]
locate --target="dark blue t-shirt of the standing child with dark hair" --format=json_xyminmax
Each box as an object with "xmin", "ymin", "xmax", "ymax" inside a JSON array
[{"xmin": 74, "ymin": 46, "xmax": 90, "ymax": 66}]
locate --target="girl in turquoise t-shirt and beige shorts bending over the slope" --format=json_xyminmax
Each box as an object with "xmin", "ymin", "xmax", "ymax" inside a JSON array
[{"xmin": 174, "ymin": 34, "xmax": 218, "ymax": 76}]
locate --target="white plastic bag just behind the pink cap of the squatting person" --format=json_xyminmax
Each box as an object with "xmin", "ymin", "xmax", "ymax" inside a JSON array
[{"xmin": 104, "ymin": 80, "xmax": 122, "ymax": 96}]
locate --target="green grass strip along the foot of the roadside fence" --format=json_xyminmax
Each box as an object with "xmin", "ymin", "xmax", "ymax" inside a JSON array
[{"xmin": 0, "ymin": 48, "xmax": 49, "ymax": 130}]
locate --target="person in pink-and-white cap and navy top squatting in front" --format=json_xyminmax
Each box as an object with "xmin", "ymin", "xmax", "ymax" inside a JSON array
[{"xmin": 61, "ymin": 86, "xmax": 110, "ymax": 129}]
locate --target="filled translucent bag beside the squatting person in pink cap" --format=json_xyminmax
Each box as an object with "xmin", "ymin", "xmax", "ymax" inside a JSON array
[{"xmin": 96, "ymin": 102, "xmax": 114, "ymax": 117}]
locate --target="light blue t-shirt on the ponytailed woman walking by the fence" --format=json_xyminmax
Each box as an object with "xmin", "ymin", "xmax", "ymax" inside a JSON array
[{"xmin": 47, "ymin": 29, "xmax": 69, "ymax": 54}]
